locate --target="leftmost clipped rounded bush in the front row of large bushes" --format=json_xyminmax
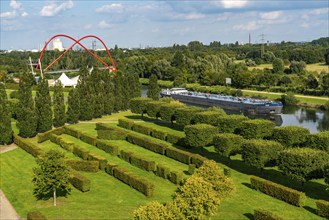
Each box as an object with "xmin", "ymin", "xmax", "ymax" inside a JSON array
[{"xmin": 184, "ymin": 124, "xmax": 217, "ymax": 147}]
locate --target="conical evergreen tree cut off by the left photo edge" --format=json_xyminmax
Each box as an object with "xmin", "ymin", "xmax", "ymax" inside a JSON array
[{"xmin": 0, "ymin": 82, "xmax": 13, "ymax": 144}]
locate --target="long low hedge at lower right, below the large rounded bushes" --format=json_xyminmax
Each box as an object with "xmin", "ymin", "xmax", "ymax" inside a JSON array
[{"xmin": 250, "ymin": 176, "xmax": 306, "ymax": 207}]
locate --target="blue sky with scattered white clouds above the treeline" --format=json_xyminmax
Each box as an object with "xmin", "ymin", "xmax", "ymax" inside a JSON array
[{"xmin": 0, "ymin": 0, "xmax": 329, "ymax": 50}]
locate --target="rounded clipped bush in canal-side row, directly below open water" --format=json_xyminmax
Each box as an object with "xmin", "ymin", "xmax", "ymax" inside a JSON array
[{"xmin": 272, "ymin": 126, "xmax": 308, "ymax": 147}]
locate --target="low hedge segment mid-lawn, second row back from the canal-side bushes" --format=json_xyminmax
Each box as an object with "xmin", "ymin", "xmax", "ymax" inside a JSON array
[{"xmin": 127, "ymin": 134, "xmax": 168, "ymax": 155}]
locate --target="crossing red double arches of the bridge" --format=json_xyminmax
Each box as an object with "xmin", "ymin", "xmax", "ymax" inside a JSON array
[{"xmin": 36, "ymin": 34, "xmax": 117, "ymax": 72}]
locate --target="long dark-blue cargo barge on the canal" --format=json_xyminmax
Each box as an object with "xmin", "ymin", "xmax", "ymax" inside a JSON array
[{"xmin": 160, "ymin": 88, "xmax": 283, "ymax": 115}]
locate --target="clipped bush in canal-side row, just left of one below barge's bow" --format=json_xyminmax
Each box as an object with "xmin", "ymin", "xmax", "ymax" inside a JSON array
[{"xmin": 217, "ymin": 115, "xmax": 249, "ymax": 133}]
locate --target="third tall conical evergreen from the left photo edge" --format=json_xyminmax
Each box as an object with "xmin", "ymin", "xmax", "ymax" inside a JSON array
[{"xmin": 35, "ymin": 79, "xmax": 53, "ymax": 132}]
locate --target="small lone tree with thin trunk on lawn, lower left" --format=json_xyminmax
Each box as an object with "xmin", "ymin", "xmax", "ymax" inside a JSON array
[{"xmin": 32, "ymin": 150, "xmax": 70, "ymax": 206}]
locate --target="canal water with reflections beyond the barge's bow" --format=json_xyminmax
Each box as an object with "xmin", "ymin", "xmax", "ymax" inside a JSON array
[{"xmin": 141, "ymin": 86, "xmax": 329, "ymax": 133}]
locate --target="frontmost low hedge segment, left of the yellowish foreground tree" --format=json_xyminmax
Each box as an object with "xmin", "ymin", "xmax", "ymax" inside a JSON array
[{"xmin": 113, "ymin": 167, "xmax": 154, "ymax": 197}]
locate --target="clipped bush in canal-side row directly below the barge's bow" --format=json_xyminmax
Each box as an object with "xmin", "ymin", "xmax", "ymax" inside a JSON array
[{"xmin": 237, "ymin": 119, "xmax": 275, "ymax": 139}]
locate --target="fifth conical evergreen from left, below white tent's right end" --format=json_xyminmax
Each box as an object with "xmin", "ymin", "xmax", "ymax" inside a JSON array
[{"xmin": 66, "ymin": 89, "xmax": 80, "ymax": 123}]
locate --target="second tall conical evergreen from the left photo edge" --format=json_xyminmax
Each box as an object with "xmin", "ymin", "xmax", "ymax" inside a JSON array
[{"xmin": 16, "ymin": 73, "xmax": 37, "ymax": 137}]
